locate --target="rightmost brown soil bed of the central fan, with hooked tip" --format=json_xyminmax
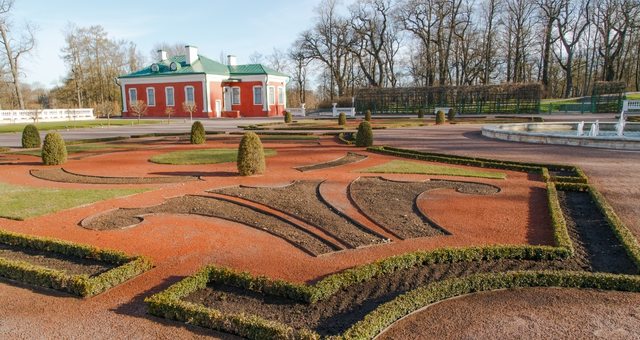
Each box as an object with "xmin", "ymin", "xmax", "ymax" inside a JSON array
[{"xmin": 349, "ymin": 177, "xmax": 500, "ymax": 239}]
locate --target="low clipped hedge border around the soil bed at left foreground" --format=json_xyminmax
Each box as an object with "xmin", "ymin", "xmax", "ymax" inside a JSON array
[{"xmin": 0, "ymin": 230, "xmax": 153, "ymax": 297}]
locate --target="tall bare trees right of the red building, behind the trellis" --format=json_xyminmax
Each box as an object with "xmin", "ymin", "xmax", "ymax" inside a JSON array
[{"xmin": 288, "ymin": 0, "xmax": 640, "ymax": 101}]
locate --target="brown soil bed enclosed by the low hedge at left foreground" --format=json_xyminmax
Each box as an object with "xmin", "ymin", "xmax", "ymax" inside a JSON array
[{"xmin": 0, "ymin": 244, "xmax": 115, "ymax": 276}]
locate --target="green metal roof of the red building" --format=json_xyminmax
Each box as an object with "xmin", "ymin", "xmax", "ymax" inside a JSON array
[{"xmin": 120, "ymin": 55, "xmax": 288, "ymax": 78}]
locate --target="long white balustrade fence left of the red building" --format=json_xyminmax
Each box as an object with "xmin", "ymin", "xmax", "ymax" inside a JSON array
[{"xmin": 0, "ymin": 109, "xmax": 95, "ymax": 124}]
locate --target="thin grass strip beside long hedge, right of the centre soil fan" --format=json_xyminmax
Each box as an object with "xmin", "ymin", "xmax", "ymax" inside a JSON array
[{"xmin": 358, "ymin": 160, "xmax": 507, "ymax": 179}]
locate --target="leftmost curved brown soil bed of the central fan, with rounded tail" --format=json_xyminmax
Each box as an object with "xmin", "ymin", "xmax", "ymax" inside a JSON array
[{"xmin": 81, "ymin": 195, "xmax": 336, "ymax": 255}]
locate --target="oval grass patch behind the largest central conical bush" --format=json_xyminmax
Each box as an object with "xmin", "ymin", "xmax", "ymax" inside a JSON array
[{"xmin": 149, "ymin": 149, "xmax": 277, "ymax": 165}]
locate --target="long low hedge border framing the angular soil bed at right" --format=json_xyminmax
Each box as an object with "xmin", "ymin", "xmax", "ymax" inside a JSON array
[{"xmin": 145, "ymin": 147, "xmax": 640, "ymax": 339}]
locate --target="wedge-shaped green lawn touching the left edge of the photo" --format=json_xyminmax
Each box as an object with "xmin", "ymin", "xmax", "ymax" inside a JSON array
[{"xmin": 0, "ymin": 183, "xmax": 148, "ymax": 220}]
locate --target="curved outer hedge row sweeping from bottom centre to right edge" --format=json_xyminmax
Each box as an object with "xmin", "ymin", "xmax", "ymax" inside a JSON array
[{"xmin": 342, "ymin": 271, "xmax": 640, "ymax": 339}]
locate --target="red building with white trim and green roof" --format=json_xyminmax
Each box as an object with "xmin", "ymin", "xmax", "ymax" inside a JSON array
[{"xmin": 118, "ymin": 46, "xmax": 289, "ymax": 118}]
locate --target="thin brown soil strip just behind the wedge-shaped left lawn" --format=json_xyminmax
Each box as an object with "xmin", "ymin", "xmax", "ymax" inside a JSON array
[{"xmin": 30, "ymin": 168, "xmax": 199, "ymax": 184}]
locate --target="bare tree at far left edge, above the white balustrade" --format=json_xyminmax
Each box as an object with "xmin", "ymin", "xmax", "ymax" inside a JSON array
[{"xmin": 0, "ymin": 0, "xmax": 36, "ymax": 110}]
